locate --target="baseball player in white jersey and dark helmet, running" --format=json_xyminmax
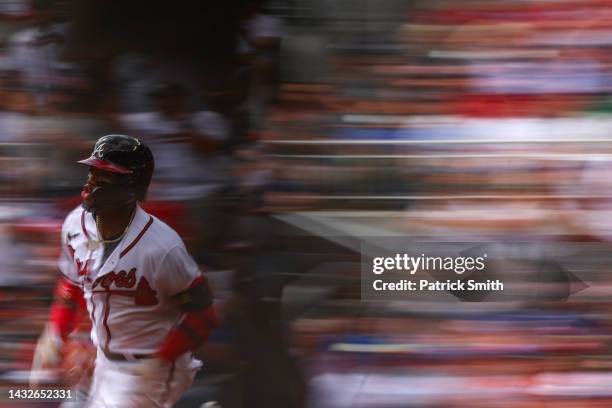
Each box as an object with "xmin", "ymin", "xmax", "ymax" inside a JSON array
[{"xmin": 33, "ymin": 135, "xmax": 218, "ymax": 408}]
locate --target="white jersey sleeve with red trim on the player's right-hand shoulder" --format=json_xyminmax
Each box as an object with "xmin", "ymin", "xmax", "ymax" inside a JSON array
[{"xmin": 155, "ymin": 244, "xmax": 202, "ymax": 296}]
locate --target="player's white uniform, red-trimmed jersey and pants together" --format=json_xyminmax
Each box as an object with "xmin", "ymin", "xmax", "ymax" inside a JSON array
[{"xmin": 58, "ymin": 206, "xmax": 201, "ymax": 408}]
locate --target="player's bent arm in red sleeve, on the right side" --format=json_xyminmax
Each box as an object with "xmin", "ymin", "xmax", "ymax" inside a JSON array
[{"xmin": 157, "ymin": 276, "xmax": 219, "ymax": 361}]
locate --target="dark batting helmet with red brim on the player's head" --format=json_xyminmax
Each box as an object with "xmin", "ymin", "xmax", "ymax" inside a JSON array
[{"xmin": 78, "ymin": 135, "xmax": 155, "ymax": 207}]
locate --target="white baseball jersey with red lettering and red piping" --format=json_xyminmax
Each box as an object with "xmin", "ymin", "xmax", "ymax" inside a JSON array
[{"xmin": 58, "ymin": 206, "xmax": 201, "ymax": 354}]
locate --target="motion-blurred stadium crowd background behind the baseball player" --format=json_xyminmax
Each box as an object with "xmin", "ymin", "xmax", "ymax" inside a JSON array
[{"xmin": 0, "ymin": 0, "xmax": 612, "ymax": 408}]
